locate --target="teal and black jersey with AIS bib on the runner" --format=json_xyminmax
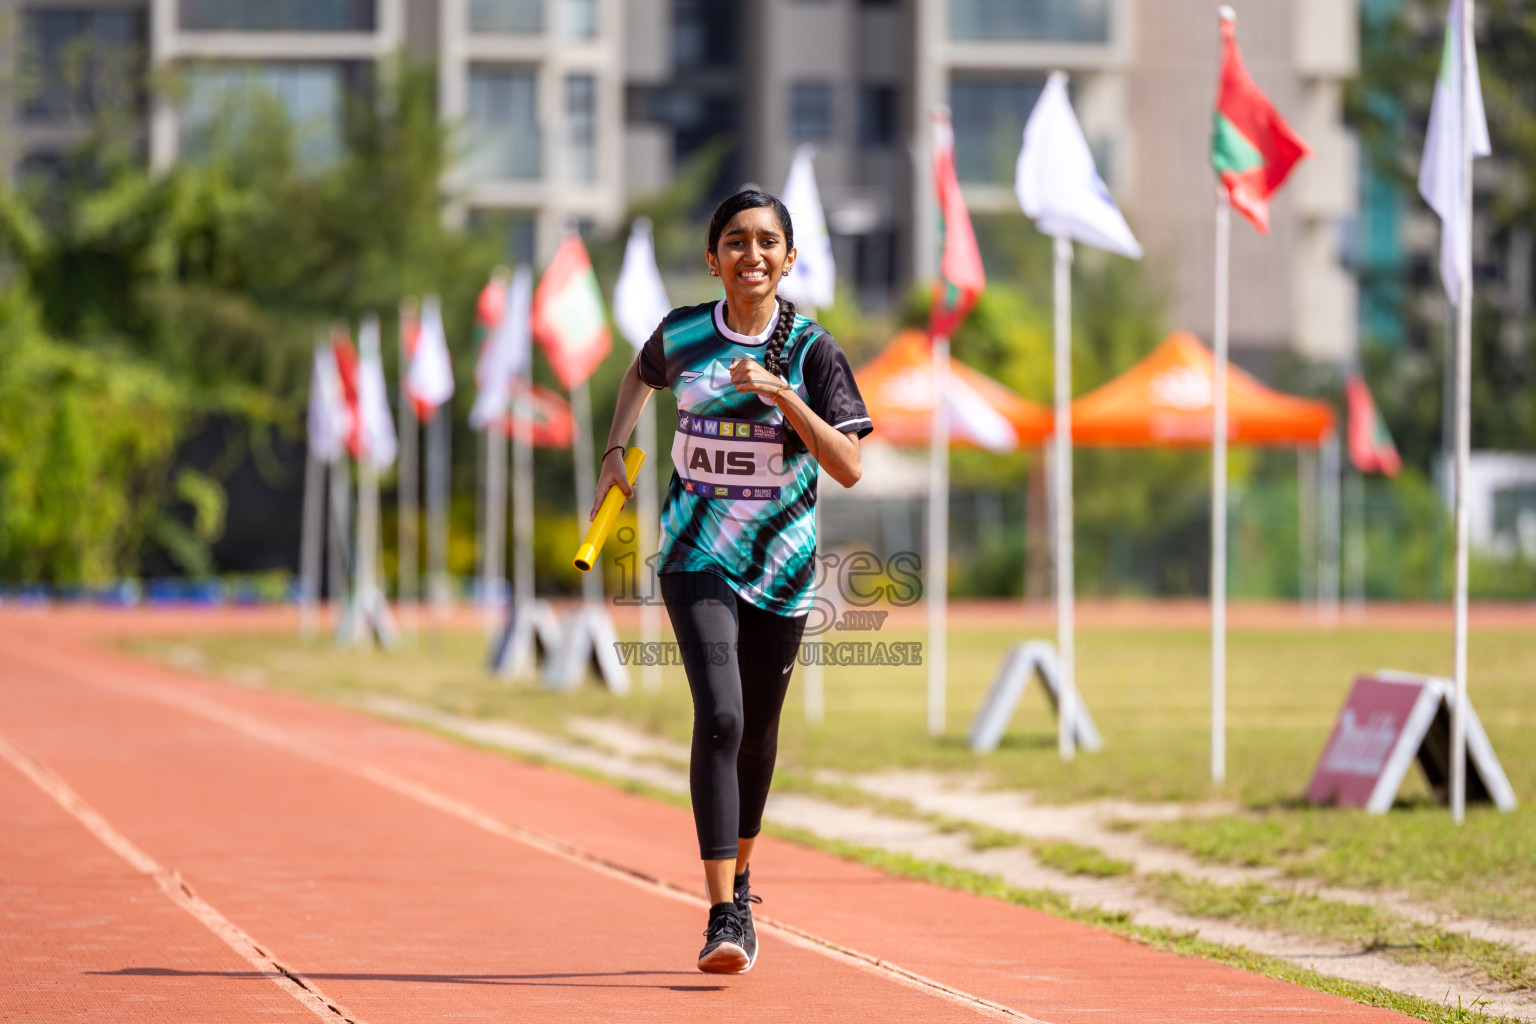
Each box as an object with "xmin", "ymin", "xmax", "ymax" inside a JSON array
[{"xmin": 639, "ymin": 301, "xmax": 872, "ymax": 616}]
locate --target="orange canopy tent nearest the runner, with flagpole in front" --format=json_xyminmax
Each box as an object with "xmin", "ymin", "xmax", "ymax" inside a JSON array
[{"xmin": 854, "ymin": 329, "xmax": 1052, "ymax": 451}]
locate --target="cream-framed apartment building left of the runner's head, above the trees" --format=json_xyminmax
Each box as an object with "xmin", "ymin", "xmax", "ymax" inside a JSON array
[{"xmin": 0, "ymin": 0, "xmax": 627, "ymax": 259}]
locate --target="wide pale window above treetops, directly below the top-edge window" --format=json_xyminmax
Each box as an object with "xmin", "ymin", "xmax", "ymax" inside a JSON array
[{"xmin": 180, "ymin": 61, "xmax": 354, "ymax": 169}]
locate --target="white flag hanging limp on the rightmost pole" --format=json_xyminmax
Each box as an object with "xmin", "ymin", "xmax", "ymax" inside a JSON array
[{"xmin": 1419, "ymin": 0, "xmax": 1493, "ymax": 306}]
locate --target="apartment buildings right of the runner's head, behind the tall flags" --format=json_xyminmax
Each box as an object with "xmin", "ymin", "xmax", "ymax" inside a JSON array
[{"xmin": 611, "ymin": 0, "xmax": 1358, "ymax": 362}]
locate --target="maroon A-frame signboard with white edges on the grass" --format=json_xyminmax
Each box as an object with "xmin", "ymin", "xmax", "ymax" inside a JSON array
[{"xmin": 1307, "ymin": 671, "xmax": 1514, "ymax": 814}]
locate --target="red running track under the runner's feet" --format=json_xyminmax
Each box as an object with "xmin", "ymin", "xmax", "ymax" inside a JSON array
[{"xmin": 0, "ymin": 613, "xmax": 1407, "ymax": 1024}]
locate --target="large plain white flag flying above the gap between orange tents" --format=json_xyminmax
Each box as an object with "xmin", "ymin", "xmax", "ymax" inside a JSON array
[{"xmin": 1014, "ymin": 71, "xmax": 1141, "ymax": 259}]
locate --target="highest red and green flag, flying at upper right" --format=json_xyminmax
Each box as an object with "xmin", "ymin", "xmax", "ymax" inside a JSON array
[{"xmin": 1210, "ymin": 15, "xmax": 1312, "ymax": 235}]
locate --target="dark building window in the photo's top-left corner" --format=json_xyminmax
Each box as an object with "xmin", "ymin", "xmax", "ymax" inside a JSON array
[{"xmin": 18, "ymin": 11, "xmax": 144, "ymax": 121}]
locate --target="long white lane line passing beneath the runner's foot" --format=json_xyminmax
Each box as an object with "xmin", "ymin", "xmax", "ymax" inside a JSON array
[{"xmin": 12, "ymin": 649, "xmax": 1046, "ymax": 1024}]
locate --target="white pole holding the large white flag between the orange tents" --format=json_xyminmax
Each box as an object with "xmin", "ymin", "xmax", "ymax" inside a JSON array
[{"xmin": 1052, "ymin": 235, "xmax": 1077, "ymax": 761}]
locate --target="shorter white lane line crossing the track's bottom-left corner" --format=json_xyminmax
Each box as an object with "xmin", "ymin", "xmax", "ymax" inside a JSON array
[{"xmin": 0, "ymin": 732, "xmax": 358, "ymax": 1024}]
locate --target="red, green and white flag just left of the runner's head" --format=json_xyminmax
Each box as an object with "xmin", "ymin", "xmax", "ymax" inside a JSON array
[{"xmin": 533, "ymin": 232, "xmax": 613, "ymax": 391}]
